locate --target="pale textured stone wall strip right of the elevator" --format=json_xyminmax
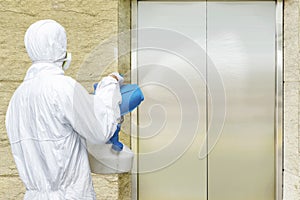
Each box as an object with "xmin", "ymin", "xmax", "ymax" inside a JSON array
[{"xmin": 283, "ymin": 0, "xmax": 300, "ymax": 200}]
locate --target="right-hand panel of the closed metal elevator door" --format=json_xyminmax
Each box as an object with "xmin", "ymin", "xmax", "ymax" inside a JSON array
[{"xmin": 207, "ymin": 1, "xmax": 275, "ymax": 200}]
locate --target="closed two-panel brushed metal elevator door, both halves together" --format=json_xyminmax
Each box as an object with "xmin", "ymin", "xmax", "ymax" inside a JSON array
[{"xmin": 137, "ymin": 1, "xmax": 276, "ymax": 200}]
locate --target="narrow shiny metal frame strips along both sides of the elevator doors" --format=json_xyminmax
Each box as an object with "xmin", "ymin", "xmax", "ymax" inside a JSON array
[{"xmin": 131, "ymin": 0, "xmax": 283, "ymax": 200}]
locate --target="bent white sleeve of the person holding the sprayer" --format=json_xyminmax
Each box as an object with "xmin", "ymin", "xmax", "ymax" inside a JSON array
[{"xmin": 66, "ymin": 77, "xmax": 122, "ymax": 144}]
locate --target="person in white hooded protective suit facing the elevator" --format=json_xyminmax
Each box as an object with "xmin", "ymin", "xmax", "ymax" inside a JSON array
[{"xmin": 6, "ymin": 20, "xmax": 123, "ymax": 200}]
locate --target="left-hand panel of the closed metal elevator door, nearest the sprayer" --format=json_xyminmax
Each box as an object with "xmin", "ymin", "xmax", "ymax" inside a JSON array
[{"xmin": 137, "ymin": 2, "xmax": 207, "ymax": 200}]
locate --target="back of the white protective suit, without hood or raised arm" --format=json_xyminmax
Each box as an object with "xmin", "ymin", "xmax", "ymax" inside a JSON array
[{"xmin": 6, "ymin": 64, "xmax": 95, "ymax": 199}]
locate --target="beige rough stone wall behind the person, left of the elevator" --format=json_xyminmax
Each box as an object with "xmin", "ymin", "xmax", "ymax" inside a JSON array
[{"xmin": 0, "ymin": 0, "xmax": 130, "ymax": 200}]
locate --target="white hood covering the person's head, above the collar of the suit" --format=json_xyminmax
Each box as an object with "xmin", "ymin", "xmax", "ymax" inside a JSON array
[{"xmin": 24, "ymin": 19, "xmax": 67, "ymax": 65}]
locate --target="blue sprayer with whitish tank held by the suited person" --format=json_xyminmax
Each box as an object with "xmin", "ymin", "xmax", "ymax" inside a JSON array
[{"xmin": 88, "ymin": 83, "xmax": 144, "ymax": 174}]
